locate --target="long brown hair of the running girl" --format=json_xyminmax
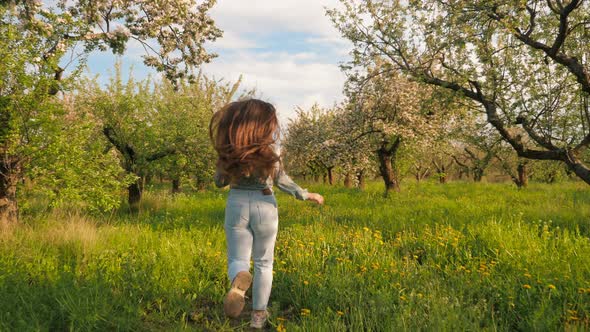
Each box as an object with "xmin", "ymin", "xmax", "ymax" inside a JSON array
[{"xmin": 209, "ymin": 99, "xmax": 279, "ymax": 182}]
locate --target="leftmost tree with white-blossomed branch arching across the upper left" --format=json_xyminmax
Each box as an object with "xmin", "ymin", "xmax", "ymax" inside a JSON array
[{"xmin": 0, "ymin": 0, "xmax": 221, "ymax": 224}]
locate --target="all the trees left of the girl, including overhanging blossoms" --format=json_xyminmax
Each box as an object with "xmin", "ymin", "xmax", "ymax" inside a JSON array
[{"xmin": 0, "ymin": 0, "xmax": 230, "ymax": 224}]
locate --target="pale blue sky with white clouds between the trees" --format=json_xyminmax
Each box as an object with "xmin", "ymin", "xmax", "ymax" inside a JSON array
[{"xmin": 83, "ymin": 0, "xmax": 351, "ymax": 123}]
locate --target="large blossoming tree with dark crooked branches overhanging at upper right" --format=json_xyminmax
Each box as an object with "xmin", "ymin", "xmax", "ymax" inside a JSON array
[{"xmin": 328, "ymin": 0, "xmax": 590, "ymax": 184}]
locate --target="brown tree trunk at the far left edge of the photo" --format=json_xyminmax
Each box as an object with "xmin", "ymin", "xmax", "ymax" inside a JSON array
[{"xmin": 0, "ymin": 157, "xmax": 21, "ymax": 226}]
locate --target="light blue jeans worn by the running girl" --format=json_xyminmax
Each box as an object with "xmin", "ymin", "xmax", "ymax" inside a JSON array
[{"xmin": 225, "ymin": 189, "xmax": 279, "ymax": 310}]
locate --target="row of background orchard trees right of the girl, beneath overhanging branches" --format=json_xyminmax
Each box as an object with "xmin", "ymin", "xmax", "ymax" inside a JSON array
[{"xmin": 283, "ymin": 97, "xmax": 575, "ymax": 193}]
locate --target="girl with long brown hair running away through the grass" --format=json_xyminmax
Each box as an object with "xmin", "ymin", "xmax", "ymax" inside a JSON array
[{"xmin": 209, "ymin": 99, "xmax": 324, "ymax": 328}]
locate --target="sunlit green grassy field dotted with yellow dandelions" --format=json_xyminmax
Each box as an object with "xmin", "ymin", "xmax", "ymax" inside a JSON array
[{"xmin": 0, "ymin": 183, "xmax": 590, "ymax": 331}]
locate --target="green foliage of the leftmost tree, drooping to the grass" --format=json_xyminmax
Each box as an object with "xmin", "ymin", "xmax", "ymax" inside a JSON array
[{"xmin": 0, "ymin": 7, "xmax": 130, "ymax": 215}]
